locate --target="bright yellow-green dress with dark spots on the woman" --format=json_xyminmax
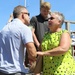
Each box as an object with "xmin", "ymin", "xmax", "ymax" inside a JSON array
[{"xmin": 41, "ymin": 30, "xmax": 75, "ymax": 75}]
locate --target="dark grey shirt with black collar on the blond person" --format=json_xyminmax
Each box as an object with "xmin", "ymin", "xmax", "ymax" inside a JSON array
[{"xmin": 30, "ymin": 14, "xmax": 48, "ymax": 42}]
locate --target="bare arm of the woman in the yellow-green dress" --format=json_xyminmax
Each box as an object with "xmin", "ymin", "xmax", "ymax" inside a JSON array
[{"xmin": 37, "ymin": 33, "xmax": 71, "ymax": 56}]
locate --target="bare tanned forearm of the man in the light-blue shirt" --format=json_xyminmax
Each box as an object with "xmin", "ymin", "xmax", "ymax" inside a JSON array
[{"xmin": 26, "ymin": 42, "xmax": 37, "ymax": 71}]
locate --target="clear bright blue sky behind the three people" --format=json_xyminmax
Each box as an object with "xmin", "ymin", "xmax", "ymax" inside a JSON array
[{"xmin": 0, "ymin": 0, "xmax": 75, "ymax": 30}]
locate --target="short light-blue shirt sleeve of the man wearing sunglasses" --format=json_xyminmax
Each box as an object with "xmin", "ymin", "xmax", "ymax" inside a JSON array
[{"xmin": 22, "ymin": 27, "xmax": 33, "ymax": 44}]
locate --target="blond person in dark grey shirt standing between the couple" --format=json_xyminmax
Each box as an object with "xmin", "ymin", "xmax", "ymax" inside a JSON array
[{"xmin": 30, "ymin": 2, "xmax": 51, "ymax": 48}]
